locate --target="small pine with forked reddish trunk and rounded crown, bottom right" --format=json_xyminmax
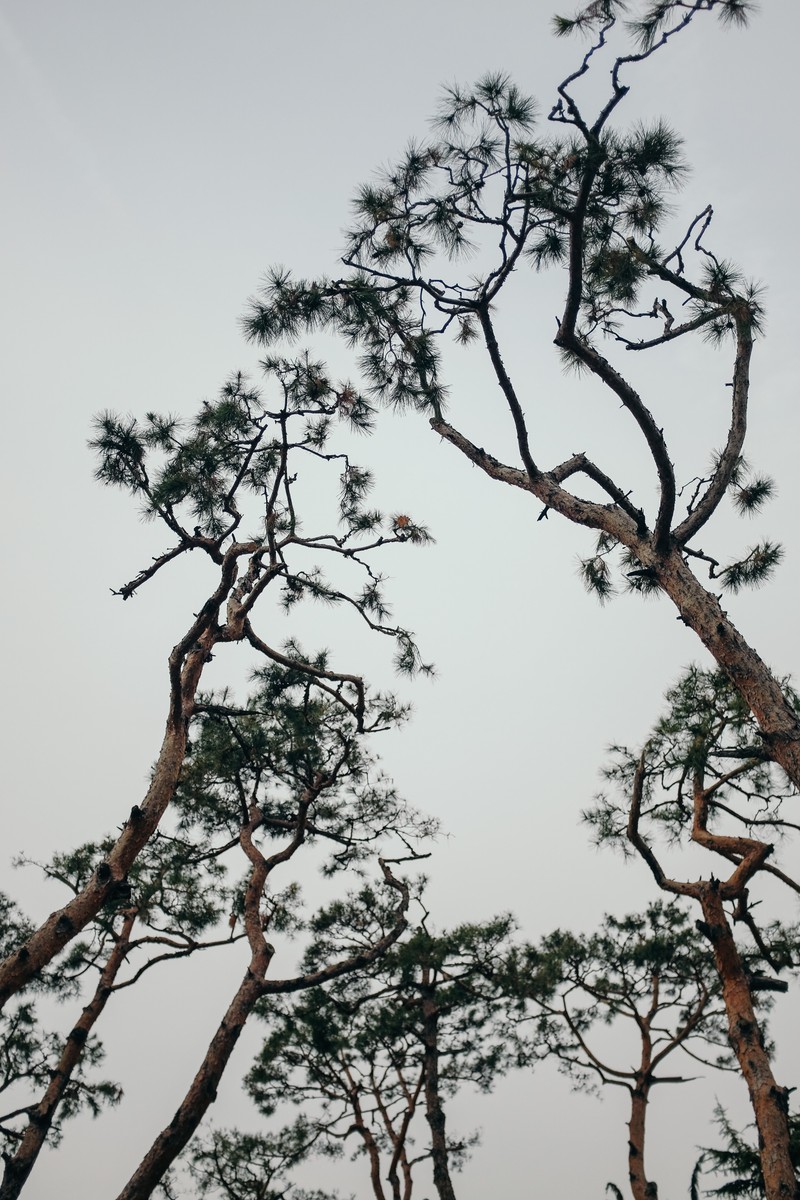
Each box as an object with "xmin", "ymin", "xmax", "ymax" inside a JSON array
[{"xmin": 509, "ymin": 901, "xmax": 736, "ymax": 1200}]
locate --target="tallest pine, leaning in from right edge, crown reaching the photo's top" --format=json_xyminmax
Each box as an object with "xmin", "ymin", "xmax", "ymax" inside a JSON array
[{"xmin": 245, "ymin": 0, "xmax": 800, "ymax": 786}]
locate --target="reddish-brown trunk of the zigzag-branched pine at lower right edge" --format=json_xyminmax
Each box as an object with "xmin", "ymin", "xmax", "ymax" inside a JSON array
[{"xmin": 699, "ymin": 882, "xmax": 800, "ymax": 1200}]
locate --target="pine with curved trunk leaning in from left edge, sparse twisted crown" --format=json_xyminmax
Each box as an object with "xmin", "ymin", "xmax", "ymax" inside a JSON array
[{"xmin": 0, "ymin": 356, "xmax": 431, "ymax": 1004}]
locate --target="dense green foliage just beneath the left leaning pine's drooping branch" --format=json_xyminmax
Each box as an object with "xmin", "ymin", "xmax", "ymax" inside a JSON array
[{"xmin": 175, "ymin": 667, "xmax": 437, "ymax": 871}]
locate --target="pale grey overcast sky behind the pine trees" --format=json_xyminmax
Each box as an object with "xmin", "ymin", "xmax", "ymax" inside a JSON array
[{"xmin": 0, "ymin": 0, "xmax": 800, "ymax": 1200}]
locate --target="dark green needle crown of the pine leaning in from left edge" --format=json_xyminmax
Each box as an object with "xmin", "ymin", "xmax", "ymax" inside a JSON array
[{"xmin": 90, "ymin": 355, "xmax": 432, "ymax": 673}]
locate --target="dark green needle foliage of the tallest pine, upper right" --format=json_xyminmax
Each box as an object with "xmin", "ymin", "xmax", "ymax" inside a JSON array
[{"xmin": 243, "ymin": 0, "xmax": 767, "ymax": 624}]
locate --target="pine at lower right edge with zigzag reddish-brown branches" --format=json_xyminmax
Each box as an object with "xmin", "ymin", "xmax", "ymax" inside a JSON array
[{"xmin": 585, "ymin": 667, "xmax": 800, "ymax": 1200}]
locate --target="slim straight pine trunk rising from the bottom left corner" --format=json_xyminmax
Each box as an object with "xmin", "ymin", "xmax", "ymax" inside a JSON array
[{"xmin": 0, "ymin": 912, "xmax": 136, "ymax": 1200}]
